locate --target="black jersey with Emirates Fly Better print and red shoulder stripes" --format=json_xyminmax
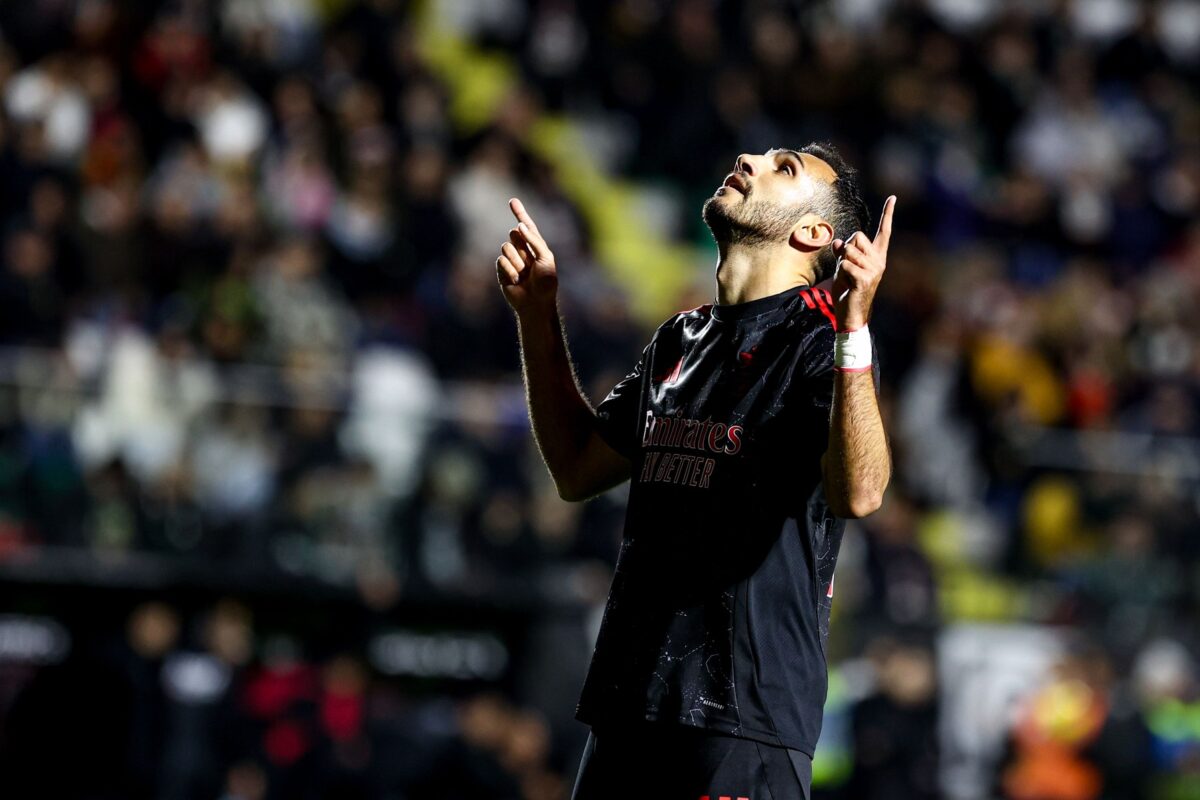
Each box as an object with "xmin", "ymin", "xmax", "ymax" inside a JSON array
[{"xmin": 575, "ymin": 287, "xmax": 873, "ymax": 756}]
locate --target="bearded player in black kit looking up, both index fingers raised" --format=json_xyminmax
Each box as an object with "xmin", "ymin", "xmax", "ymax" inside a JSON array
[{"xmin": 497, "ymin": 144, "xmax": 895, "ymax": 800}]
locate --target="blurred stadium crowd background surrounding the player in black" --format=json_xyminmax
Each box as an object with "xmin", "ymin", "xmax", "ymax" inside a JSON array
[{"xmin": 0, "ymin": 0, "xmax": 1200, "ymax": 800}]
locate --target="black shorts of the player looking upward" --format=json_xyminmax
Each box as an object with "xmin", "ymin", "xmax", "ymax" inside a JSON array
[{"xmin": 571, "ymin": 722, "xmax": 812, "ymax": 800}]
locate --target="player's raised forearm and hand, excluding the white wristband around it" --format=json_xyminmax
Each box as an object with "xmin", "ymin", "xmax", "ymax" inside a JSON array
[{"xmin": 821, "ymin": 196, "xmax": 896, "ymax": 517}]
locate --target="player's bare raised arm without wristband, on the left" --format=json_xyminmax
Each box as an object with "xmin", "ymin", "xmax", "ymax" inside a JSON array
[{"xmin": 496, "ymin": 198, "xmax": 631, "ymax": 500}]
